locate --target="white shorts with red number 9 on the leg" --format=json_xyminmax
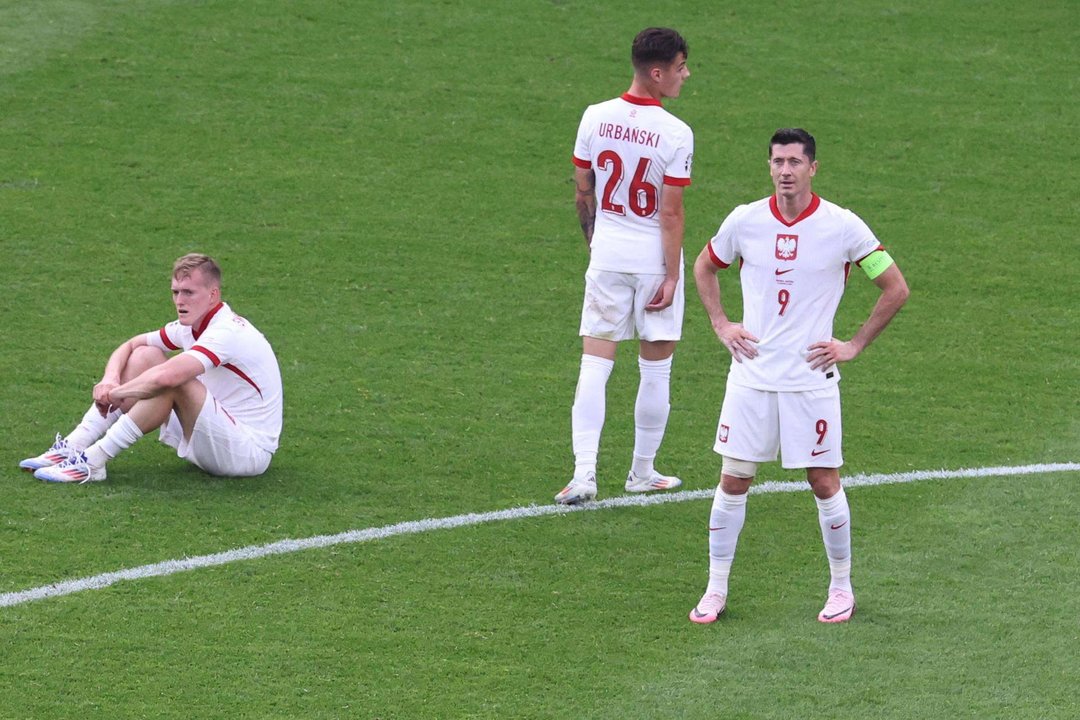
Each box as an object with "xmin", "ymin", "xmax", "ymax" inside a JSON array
[{"xmin": 713, "ymin": 381, "xmax": 843, "ymax": 468}]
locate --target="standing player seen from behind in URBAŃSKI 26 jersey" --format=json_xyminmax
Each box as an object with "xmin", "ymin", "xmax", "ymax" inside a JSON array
[{"xmin": 555, "ymin": 28, "xmax": 693, "ymax": 504}]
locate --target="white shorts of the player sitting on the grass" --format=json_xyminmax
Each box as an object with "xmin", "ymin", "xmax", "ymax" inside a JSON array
[{"xmin": 158, "ymin": 390, "xmax": 272, "ymax": 477}]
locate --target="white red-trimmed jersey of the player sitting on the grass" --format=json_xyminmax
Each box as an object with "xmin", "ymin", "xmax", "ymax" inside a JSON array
[{"xmin": 144, "ymin": 302, "xmax": 282, "ymax": 452}]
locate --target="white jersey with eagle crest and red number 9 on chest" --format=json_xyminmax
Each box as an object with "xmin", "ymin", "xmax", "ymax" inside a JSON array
[{"xmin": 707, "ymin": 194, "xmax": 881, "ymax": 392}]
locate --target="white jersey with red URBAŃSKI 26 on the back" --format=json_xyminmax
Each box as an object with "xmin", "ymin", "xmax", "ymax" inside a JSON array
[{"xmin": 573, "ymin": 94, "xmax": 693, "ymax": 274}]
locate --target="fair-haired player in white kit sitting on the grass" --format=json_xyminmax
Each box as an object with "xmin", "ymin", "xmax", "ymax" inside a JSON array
[{"xmin": 18, "ymin": 254, "xmax": 282, "ymax": 483}]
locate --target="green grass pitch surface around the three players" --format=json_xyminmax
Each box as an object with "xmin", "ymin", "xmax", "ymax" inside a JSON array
[{"xmin": 0, "ymin": 2, "xmax": 1080, "ymax": 718}]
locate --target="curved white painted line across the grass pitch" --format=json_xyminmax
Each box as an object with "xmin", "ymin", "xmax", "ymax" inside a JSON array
[{"xmin": 0, "ymin": 462, "xmax": 1080, "ymax": 608}]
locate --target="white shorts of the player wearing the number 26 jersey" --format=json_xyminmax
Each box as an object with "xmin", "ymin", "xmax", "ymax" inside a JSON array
[{"xmin": 579, "ymin": 269, "xmax": 686, "ymax": 342}]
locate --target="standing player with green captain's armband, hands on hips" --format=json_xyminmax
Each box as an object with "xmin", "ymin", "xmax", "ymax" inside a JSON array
[{"xmin": 690, "ymin": 128, "xmax": 907, "ymax": 623}]
